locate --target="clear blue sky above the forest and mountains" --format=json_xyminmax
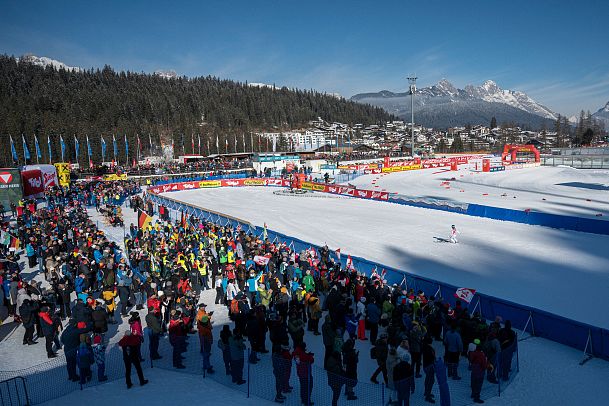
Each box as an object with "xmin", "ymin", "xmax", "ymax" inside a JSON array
[{"xmin": 0, "ymin": 0, "xmax": 609, "ymax": 115}]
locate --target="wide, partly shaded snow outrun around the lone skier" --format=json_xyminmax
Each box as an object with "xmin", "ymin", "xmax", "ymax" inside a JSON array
[{"xmin": 167, "ymin": 187, "xmax": 609, "ymax": 328}]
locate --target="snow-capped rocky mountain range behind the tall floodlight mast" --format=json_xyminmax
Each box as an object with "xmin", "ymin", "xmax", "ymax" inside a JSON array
[{"xmin": 351, "ymin": 79, "xmax": 556, "ymax": 127}]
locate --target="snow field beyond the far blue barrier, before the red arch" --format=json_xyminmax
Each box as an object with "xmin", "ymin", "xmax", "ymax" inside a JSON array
[{"xmin": 350, "ymin": 165, "xmax": 609, "ymax": 220}]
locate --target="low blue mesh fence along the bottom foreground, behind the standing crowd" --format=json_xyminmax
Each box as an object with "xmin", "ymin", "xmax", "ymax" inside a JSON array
[{"xmin": 0, "ymin": 326, "xmax": 518, "ymax": 406}]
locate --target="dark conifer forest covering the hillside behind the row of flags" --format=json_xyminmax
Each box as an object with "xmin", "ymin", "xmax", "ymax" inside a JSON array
[{"xmin": 0, "ymin": 55, "xmax": 395, "ymax": 166}]
